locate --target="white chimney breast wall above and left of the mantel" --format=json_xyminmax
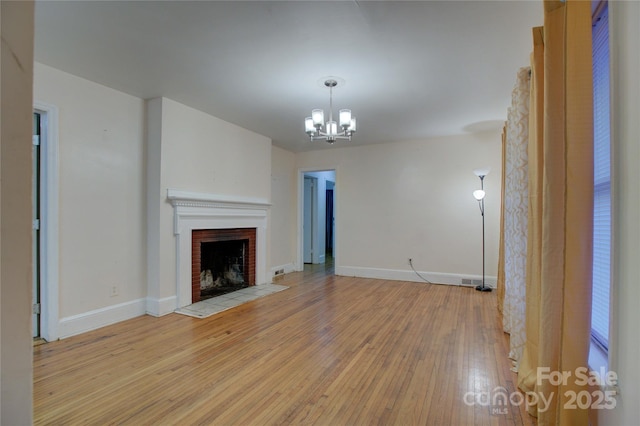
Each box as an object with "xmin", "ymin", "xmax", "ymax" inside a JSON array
[{"xmin": 147, "ymin": 98, "xmax": 271, "ymax": 315}]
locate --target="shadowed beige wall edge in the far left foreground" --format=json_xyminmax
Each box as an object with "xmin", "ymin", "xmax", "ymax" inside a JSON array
[{"xmin": 0, "ymin": 1, "xmax": 33, "ymax": 425}]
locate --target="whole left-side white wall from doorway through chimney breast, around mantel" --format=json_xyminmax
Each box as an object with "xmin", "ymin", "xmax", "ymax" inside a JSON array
[{"xmin": 34, "ymin": 63, "xmax": 271, "ymax": 337}]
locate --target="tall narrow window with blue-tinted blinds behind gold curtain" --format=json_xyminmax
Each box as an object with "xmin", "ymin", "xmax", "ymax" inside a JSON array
[{"xmin": 590, "ymin": 2, "xmax": 611, "ymax": 358}]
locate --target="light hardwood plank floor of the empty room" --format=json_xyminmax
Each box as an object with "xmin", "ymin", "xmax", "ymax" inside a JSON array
[{"xmin": 34, "ymin": 266, "xmax": 534, "ymax": 425}]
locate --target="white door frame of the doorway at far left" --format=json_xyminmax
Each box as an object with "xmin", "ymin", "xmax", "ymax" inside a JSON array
[{"xmin": 33, "ymin": 101, "xmax": 59, "ymax": 341}]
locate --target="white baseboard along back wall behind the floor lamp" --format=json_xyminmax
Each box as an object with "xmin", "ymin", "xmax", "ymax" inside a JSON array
[{"xmin": 336, "ymin": 266, "xmax": 497, "ymax": 288}]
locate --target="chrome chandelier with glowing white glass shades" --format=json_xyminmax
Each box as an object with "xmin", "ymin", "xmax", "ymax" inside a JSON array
[{"xmin": 304, "ymin": 80, "xmax": 356, "ymax": 143}]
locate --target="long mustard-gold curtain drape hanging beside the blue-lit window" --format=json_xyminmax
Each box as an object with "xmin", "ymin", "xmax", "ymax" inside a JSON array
[{"xmin": 518, "ymin": 0, "xmax": 593, "ymax": 425}]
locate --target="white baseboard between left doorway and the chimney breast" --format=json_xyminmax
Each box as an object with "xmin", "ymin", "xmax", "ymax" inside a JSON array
[{"xmin": 58, "ymin": 299, "xmax": 146, "ymax": 339}]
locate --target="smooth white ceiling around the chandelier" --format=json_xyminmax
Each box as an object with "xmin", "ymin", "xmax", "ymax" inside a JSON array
[{"xmin": 35, "ymin": 0, "xmax": 542, "ymax": 152}]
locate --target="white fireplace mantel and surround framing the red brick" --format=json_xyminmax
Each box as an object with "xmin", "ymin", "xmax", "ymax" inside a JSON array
[{"xmin": 167, "ymin": 189, "xmax": 270, "ymax": 308}]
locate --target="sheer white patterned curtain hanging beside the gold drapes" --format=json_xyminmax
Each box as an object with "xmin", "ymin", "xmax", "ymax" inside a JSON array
[{"xmin": 502, "ymin": 67, "xmax": 530, "ymax": 371}]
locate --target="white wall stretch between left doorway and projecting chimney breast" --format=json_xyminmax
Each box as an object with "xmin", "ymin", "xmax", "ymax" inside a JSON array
[{"xmin": 34, "ymin": 63, "xmax": 146, "ymax": 337}]
